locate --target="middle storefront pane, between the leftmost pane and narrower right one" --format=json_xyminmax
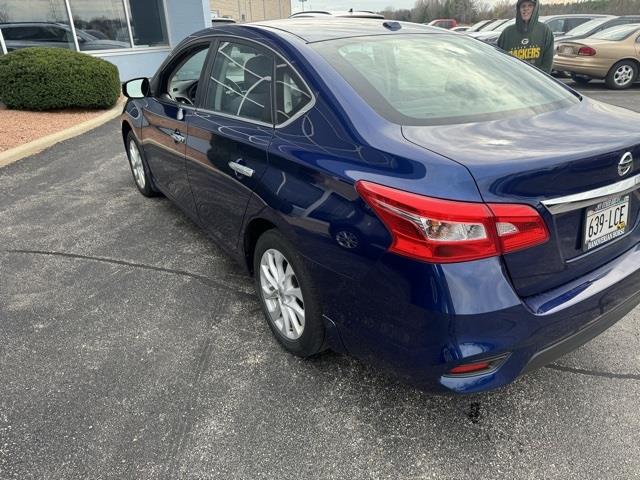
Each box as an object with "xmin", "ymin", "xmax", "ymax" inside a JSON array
[{"xmin": 69, "ymin": 0, "xmax": 131, "ymax": 52}]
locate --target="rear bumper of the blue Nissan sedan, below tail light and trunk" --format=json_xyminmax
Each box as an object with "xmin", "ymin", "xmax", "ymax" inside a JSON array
[{"xmin": 312, "ymin": 240, "xmax": 640, "ymax": 393}]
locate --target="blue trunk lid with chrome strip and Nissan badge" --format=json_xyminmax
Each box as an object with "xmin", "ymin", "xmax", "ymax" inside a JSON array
[{"xmin": 403, "ymin": 99, "xmax": 640, "ymax": 296}]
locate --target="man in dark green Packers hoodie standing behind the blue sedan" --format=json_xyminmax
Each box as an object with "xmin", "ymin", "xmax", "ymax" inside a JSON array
[{"xmin": 498, "ymin": 0, "xmax": 553, "ymax": 73}]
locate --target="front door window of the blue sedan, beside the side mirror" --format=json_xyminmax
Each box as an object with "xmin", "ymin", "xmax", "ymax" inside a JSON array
[{"xmin": 165, "ymin": 44, "xmax": 209, "ymax": 105}]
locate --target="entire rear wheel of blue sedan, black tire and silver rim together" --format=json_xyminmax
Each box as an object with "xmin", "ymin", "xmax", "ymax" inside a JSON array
[{"xmin": 253, "ymin": 229, "xmax": 325, "ymax": 357}]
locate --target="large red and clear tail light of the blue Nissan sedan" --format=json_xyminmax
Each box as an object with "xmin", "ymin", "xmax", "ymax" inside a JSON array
[{"xmin": 356, "ymin": 181, "xmax": 549, "ymax": 263}]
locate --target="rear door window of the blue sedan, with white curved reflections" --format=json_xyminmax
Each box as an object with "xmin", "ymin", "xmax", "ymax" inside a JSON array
[{"xmin": 205, "ymin": 42, "xmax": 274, "ymax": 123}]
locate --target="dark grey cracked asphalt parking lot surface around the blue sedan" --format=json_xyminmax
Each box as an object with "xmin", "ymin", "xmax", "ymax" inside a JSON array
[{"xmin": 0, "ymin": 83, "xmax": 640, "ymax": 480}]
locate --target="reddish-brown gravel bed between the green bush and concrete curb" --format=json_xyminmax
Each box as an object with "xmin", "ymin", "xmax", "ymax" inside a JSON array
[{"xmin": 0, "ymin": 109, "xmax": 106, "ymax": 152}]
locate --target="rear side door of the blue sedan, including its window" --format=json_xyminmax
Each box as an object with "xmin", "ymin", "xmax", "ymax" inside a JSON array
[{"xmin": 186, "ymin": 39, "xmax": 274, "ymax": 250}]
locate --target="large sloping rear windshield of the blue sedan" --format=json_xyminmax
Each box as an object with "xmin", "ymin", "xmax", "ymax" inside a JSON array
[{"xmin": 312, "ymin": 34, "xmax": 579, "ymax": 125}]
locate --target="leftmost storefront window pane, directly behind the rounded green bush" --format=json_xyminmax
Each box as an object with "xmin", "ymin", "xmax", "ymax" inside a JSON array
[{"xmin": 0, "ymin": 0, "xmax": 75, "ymax": 51}]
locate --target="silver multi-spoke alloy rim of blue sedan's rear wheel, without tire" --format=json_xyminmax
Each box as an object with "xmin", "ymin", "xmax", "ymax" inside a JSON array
[{"xmin": 260, "ymin": 249, "xmax": 305, "ymax": 340}]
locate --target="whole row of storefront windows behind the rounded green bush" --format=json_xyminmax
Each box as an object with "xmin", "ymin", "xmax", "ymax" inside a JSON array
[{"xmin": 0, "ymin": 0, "xmax": 169, "ymax": 54}]
